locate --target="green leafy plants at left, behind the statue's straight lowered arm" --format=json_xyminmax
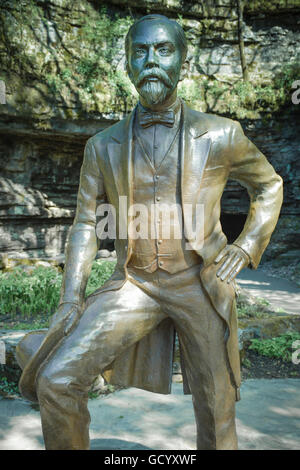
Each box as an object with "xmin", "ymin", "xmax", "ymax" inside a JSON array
[{"xmin": 0, "ymin": 260, "xmax": 116, "ymax": 329}]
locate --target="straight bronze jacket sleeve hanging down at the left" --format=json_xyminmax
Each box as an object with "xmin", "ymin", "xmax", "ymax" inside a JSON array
[{"xmin": 60, "ymin": 140, "xmax": 106, "ymax": 304}]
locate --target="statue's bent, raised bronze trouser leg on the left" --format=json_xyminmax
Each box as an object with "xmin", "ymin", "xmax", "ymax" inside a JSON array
[{"xmin": 36, "ymin": 281, "xmax": 165, "ymax": 450}]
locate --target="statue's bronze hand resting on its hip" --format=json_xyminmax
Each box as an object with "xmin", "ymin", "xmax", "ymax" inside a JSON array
[{"xmin": 214, "ymin": 245, "xmax": 250, "ymax": 283}]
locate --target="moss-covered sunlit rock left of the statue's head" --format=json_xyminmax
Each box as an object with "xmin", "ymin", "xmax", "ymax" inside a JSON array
[{"xmin": 0, "ymin": 0, "xmax": 135, "ymax": 113}]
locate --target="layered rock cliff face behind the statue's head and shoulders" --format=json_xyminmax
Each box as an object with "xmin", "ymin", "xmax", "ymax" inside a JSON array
[{"xmin": 0, "ymin": 0, "xmax": 300, "ymax": 257}]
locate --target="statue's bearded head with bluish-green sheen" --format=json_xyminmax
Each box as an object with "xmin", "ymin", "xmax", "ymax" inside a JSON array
[{"xmin": 125, "ymin": 15, "xmax": 188, "ymax": 108}]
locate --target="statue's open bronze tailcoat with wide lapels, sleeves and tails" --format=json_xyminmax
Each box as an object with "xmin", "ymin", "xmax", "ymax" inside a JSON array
[{"xmin": 63, "ymin": 104, "xmax": 282, "ymax": 393}]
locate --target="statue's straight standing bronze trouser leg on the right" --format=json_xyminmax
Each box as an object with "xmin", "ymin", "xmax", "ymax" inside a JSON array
[{"xmin": 146, "ymin": 266, "xmax": 237, "ymax": 450}]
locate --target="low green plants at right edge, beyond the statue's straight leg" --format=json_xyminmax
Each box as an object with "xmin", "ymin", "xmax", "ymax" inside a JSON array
[{"xmin": 249, "ymin": 332, "xmax": 300, "ymax": 361}]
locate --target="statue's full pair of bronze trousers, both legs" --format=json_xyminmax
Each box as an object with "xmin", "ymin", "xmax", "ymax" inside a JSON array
[{"xmin": 36, "ymin": 265, "xmax": 237, "ymax": 450}]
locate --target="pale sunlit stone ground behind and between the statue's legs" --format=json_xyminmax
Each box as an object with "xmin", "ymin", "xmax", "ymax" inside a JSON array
[{"xmin": 0, "ymin": 379, "xmax": 300, "ymax": 450}]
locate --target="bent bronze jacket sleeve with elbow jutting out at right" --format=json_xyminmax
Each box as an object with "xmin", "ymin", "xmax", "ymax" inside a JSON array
[{"xmin": 229, "ymin": 122, "xmax": 283, "ymax": 269}]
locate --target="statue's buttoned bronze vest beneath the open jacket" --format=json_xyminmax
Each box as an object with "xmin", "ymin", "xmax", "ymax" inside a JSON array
[{"xmin": 128, "ymin": 109, "xmax": 202, "ymax": 273}]
